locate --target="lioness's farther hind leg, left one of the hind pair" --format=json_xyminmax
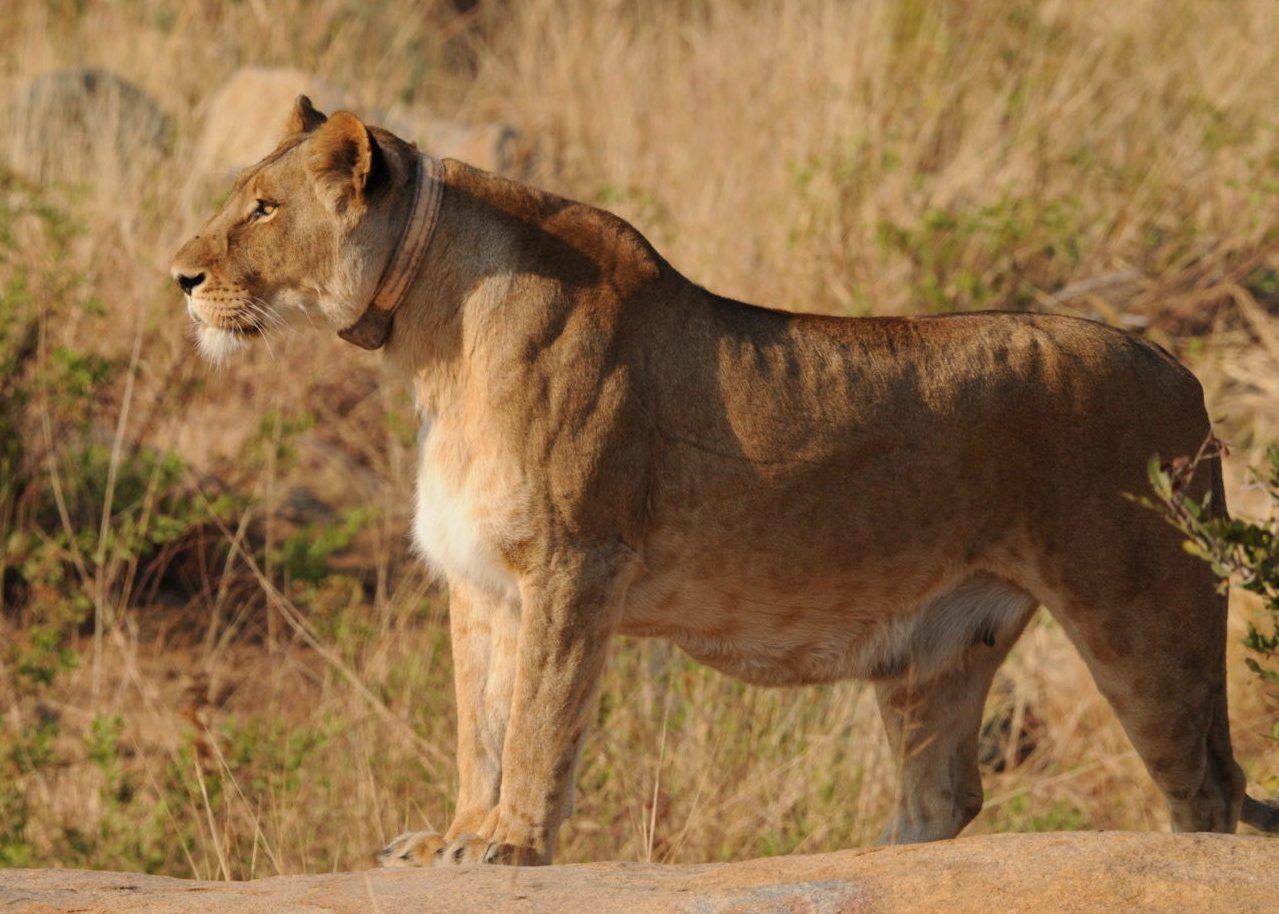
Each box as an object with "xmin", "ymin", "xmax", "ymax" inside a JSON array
[{"xmin": 876, "ymin": 575, "xmax": 1037, "ymax": 844}]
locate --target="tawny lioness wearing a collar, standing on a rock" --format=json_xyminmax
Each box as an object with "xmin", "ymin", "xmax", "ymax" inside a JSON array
[{"xmin": 173, "ymin": 97, "xmax": 1279, "ymax": 865}]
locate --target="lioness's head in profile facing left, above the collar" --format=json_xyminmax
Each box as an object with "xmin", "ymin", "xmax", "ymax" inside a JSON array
[{"xmin": 171, "ymin": 96, "xmax": 416, "ymax": 362}]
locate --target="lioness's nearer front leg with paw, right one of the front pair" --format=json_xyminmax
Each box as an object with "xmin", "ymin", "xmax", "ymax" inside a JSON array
[{"xmin": 436, "ymin": 557, "xmax": 625, "ymax": 865}]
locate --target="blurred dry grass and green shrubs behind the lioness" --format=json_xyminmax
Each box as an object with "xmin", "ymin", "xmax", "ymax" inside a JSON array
[{"xmin": 0, "ymin": 0, "xmax": 1279, "ymax": 878}]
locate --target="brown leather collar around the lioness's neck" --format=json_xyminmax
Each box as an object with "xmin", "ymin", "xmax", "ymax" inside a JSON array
[{"xmin": 338, "ymin": 153, "xmax": 444, "ymax": 349}]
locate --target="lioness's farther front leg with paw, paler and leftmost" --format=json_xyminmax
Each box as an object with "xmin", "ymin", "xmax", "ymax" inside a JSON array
[{"xmin": 377, "ymin": 580, "xmax": 519, "ymax": 867}]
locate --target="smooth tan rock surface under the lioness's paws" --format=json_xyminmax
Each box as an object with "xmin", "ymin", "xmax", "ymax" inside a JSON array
[{"xmin": 0, "ymin": 832, "xmax": 1279, "ymax": 914}]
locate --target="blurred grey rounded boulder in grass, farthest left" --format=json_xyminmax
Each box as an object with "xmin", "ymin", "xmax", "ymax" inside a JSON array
[{"xmin": 0, "ymin": 69, "xmax": 170, "ymax": 190}]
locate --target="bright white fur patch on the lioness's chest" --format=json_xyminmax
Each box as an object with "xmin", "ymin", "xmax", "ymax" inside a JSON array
[{"xmin": 413, "ymin": 419, "xmax": 522, "ymax": 597}]
